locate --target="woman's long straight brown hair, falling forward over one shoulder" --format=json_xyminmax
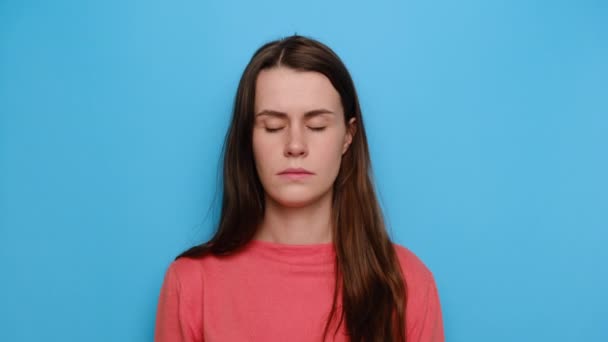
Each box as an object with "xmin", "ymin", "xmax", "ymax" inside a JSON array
[{"xmin": 175, "ymin": 35, "xmax": 407, "ymax": 342}]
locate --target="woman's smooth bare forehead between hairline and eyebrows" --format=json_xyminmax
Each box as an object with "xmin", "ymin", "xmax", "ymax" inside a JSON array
[{"xmin": 254, "ymin": 67, "xmax": 342, "ymax": 115}]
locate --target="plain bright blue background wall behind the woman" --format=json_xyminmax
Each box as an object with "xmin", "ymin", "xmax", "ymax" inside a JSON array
[{"xmin": 0, "ymin": 0, "xmax": 608, "ymax": 342}]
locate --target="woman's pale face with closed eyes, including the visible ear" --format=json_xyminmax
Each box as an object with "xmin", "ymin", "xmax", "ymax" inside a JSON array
[{"xmin": 253, "ymin": 67, "xmax": 355, "ymax": 207}]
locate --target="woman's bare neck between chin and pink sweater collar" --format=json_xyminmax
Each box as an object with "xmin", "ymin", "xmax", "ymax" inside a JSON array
[{"xmin": 254, "ymin": 192, "xmax": 332, "ymax": 244}]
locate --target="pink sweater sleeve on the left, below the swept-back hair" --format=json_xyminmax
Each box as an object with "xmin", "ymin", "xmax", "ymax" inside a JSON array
[{"xmin": 154, "ymin": 261, "xmax": 200, "ymax": 342}]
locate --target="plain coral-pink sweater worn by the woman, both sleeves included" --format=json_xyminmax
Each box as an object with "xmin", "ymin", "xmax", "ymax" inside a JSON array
[{"xmin": 154, "ymin": 240, "xmax": 444, "ymax": 342}]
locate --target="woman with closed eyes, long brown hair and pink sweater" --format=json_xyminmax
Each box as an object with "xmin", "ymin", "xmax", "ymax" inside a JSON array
[{"xmin": 155, "ymin": 35, "xmax": 444, "ymax": 342}]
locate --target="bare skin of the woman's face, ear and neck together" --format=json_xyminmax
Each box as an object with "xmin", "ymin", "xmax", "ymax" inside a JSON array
[{"xmin": 253, "ymin": 67, "xmax": 356, "ymax": 244}]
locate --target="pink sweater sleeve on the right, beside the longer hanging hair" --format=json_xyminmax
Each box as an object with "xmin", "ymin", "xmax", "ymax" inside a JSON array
[{"xmin": 408, "ymin": 275, "xmax": 445, "ymax": 342}]
